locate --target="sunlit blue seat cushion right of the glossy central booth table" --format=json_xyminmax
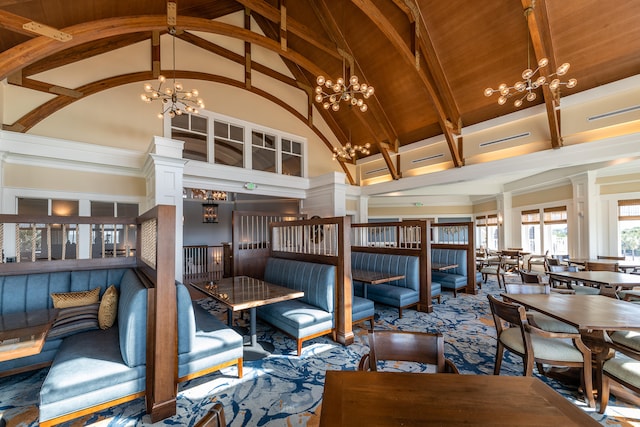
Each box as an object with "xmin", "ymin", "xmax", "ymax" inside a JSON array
[{"xmin": 257, "ymin": 300, "xmax": 333, "ymax": 338}]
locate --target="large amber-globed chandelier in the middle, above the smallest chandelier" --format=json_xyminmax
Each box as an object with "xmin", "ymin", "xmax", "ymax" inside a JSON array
[{"xmin": 315, "ymin": 75, "xmax": 374, "ymax": 113}]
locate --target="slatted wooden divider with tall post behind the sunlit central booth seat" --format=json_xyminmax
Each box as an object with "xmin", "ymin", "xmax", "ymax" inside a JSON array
[{"xmin": 269, "ymin": 217, "xmax": 354, "ymax": 345}]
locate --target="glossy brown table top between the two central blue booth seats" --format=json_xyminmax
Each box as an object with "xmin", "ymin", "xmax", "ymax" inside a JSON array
[{"xmin": 189, "ymin": 276, "xmax": 304, "ymax": 311}]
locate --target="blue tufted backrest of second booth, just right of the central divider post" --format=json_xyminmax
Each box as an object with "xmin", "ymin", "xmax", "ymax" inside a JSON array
[{"xmin": 351, "ymin": 252, "xmax": 420, "ymax": 291}]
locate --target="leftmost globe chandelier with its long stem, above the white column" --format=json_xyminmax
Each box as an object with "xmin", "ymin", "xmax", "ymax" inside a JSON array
[{"xmin": 140, "ymin": 27, "xmax": 204, "ymax": 119}]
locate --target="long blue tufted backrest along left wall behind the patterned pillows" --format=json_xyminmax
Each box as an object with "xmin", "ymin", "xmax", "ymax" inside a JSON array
[{"xmin": 0, "ymin": 268, "xmax": 128, "ymax": 315}]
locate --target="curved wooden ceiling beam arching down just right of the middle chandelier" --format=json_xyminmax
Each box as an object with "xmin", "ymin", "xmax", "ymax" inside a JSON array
[{"xmin": 351, "ymin": 0, "xmax": 464, "ymax": 167}]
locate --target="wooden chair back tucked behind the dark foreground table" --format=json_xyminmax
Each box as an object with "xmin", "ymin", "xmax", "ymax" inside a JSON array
[{"xmin": 358, "ymin": 330, "xmax": 459, "ymax": 374}]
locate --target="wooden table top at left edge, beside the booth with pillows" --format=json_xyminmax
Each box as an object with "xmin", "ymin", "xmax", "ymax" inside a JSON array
[{"xmin": 0, "ymin": 308, "xmax": 58, "ymax": 361}]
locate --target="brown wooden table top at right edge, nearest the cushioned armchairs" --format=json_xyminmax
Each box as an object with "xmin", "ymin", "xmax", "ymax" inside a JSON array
[{"xmin": 502, "ymin": 293, "xmax": 640, "ymax": 331}]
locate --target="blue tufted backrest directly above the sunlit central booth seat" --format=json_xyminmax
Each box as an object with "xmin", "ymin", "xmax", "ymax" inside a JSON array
[{"xmin": 264, "ymin": 258, "xmax": 336, "ymax": 313}]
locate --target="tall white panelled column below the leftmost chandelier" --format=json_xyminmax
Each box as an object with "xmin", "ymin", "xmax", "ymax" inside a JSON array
[{"xmin": 141, "ymin": 136, "xmax": 186, "ymax": 281}]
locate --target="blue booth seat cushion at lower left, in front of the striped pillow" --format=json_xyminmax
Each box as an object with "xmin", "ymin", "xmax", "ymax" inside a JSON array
[{"xmin": 40, "ymin": 328, "xmax": 146, "ymax": 421}]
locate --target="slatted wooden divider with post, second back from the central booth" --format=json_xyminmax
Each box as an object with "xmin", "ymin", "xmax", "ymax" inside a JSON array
[{"xmin": 351, "ymin": 220, "xmax": 433, "ymax": 313}]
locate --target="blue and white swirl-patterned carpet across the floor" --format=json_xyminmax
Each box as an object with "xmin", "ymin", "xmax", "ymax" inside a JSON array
[{"xmin": 0, "ymin": 282, "xmax": 640, "ymax": 427}]
